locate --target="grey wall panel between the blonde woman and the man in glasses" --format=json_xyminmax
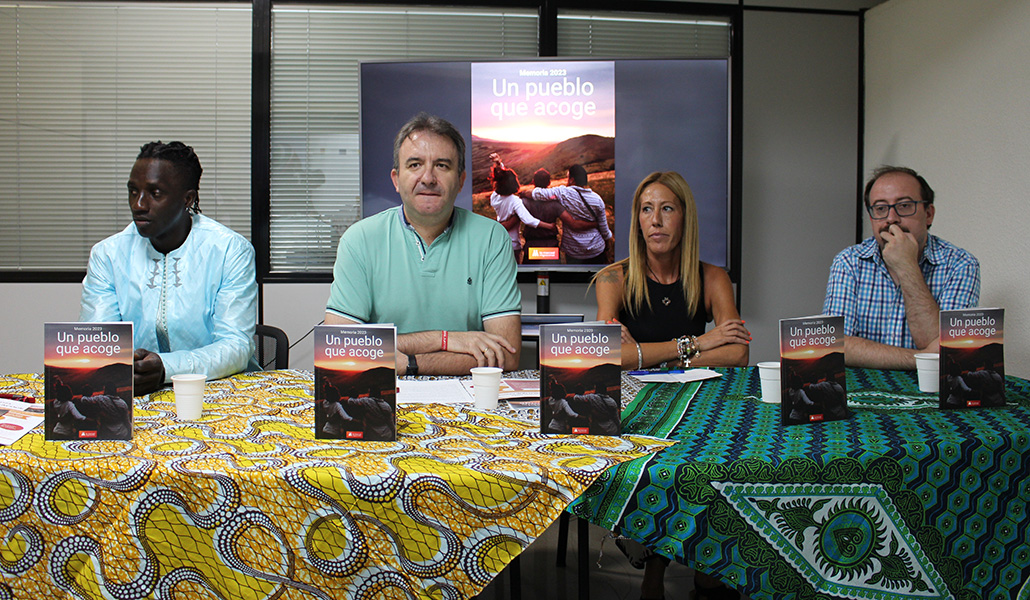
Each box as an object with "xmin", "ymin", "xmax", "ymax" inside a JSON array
[{"xmin": 741, "ymin": 10, "xmax": 859, "ymax": 364}]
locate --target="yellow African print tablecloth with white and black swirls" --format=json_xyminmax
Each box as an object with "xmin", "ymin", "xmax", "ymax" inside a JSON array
[{"xmin": 0, "ymin": 370, "xmax": 668, "ymax": 600}]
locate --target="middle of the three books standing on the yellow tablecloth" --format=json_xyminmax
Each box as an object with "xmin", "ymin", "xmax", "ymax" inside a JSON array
[{"xmin": 314, "ymin": 325, "xmax": 397, "ymax": 442}]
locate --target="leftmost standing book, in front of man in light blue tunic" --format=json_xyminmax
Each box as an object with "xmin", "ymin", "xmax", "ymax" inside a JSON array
[{"xmin": 43, "ymin": 322, "xmax": 133, "ymax": 440}]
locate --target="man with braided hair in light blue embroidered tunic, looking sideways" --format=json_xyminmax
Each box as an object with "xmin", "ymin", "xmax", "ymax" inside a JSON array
[{"xmin": 79, "ymin": 142, "xmax": 258, "ymax": 395}]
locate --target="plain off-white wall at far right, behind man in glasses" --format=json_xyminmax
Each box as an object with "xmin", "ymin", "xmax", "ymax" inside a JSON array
[{"xmin": 863, "ymin": 0, "xmax": 1030, "ymax": 377}]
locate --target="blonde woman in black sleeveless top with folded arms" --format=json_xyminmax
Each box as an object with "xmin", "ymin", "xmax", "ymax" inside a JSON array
[{"xmin": 594, "ymin": 172, "xmax": 751, "ymax": 600}]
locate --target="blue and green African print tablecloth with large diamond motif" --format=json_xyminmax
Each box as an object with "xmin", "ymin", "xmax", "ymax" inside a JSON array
[{"xmin": 570, "ymin": 368, "xmax": 1030, "ymax": 600}]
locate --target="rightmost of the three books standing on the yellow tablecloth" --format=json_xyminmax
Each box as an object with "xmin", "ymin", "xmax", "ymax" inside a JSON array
[{"xmin": 540, "ymin": 323, "xmax": 622, "ymax": 435}]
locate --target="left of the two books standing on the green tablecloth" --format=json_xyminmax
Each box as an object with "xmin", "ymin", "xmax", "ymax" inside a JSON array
[{"xmin": 780, "ymin": 315, "xmax": 851, "ymax": 425}]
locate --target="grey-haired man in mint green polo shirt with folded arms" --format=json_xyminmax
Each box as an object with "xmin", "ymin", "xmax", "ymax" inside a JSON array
[{"xmin": 325, "ymin": 113, "xmax": 522, "ymax": 375}]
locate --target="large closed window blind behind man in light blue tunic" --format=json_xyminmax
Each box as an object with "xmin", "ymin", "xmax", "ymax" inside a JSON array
[{"xmin": 0, "ymin": 1, "xmax": 251, "ymax": 272}]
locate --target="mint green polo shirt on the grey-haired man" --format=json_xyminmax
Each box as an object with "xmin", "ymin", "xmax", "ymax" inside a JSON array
[{"xmin": 325, "ymin": 207, "xmax": 522, "ymax": 334}]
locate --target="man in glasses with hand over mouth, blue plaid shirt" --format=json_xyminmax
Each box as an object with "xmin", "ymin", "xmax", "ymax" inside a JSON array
[{"xmin": 823, "ymin": 166, "xmax": 980, "ymax": 369}]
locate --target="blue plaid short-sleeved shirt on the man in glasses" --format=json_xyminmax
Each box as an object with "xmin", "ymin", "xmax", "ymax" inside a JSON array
[{"xmin": 823, "ymin": 236, "xmax": 980, "ymax": 348}]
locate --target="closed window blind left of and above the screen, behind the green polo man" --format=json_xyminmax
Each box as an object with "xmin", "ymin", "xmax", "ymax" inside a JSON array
[{"xmin": 270, "ymin": 4, "xmax": 538, "ymax": 273}]
